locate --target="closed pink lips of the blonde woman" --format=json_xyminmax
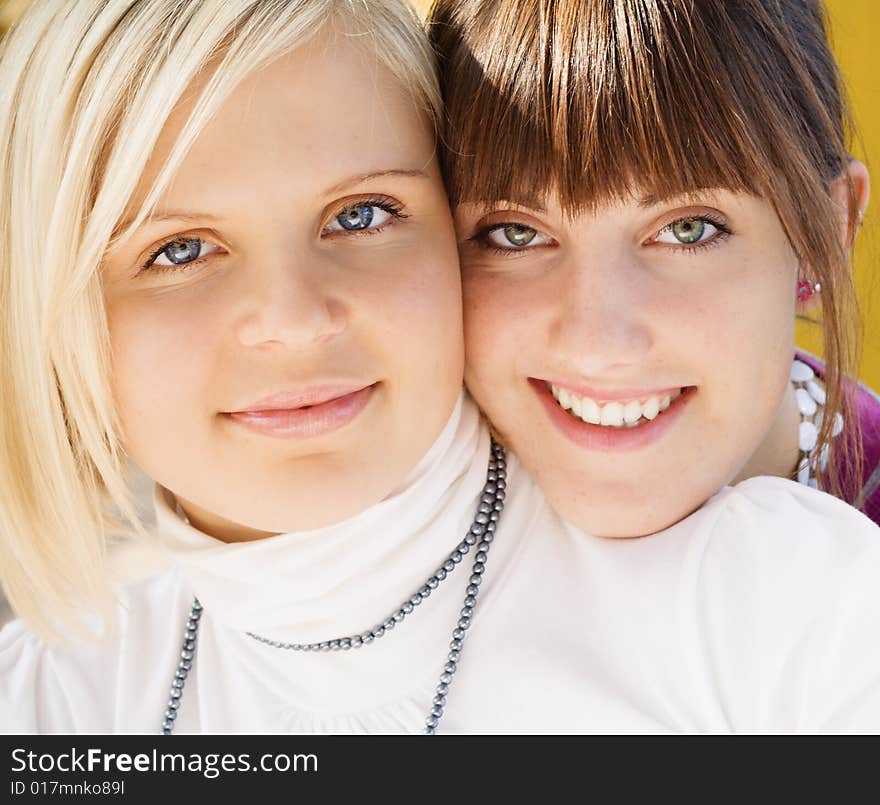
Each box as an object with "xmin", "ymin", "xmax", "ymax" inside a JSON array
[{"xmin": 223, "ymin": 383, "xmax": 378, "ymax": 439}]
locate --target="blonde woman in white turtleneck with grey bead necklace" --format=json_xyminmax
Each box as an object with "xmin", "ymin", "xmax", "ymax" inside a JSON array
[{"xmin": 0, "ymin": 0, "xmax": 880, "ymax": 734}]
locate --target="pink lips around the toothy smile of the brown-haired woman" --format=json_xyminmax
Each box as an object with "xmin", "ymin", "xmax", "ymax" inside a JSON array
[{"xmin": 529, "ymin": 378, "xmax": 696, "ymax": 453}]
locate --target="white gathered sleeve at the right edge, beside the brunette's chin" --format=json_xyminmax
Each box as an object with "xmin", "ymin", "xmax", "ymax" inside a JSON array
[{"xmin": 699, "ymin": 477, "xmax": 880, "ymax": 733}]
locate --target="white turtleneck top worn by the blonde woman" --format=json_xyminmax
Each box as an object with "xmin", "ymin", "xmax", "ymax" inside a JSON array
[{"xmin": 0, "ymin": 392, "xmax": 880, "ymax": 733}]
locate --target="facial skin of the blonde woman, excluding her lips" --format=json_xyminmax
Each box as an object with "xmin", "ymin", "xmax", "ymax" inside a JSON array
[{"xmin": 103, "ymin": 30, "xmax": 464, "ymax": 541}]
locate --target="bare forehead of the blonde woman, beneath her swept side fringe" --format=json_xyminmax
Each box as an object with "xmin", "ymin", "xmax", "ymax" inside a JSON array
[{"xmin": 130, "ymin": 31, "xmax": 434, "ymax": 217}]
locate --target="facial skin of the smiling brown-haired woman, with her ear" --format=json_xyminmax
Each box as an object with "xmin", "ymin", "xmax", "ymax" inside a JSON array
[{"xmin": 455, "ymin": 161, "xmax": 868, "ymax": 537}]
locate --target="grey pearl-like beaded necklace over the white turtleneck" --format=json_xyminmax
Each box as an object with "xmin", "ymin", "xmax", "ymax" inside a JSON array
[{"xmin": 162, "ymin": 438, "xmax": 507, "ymax": 735}]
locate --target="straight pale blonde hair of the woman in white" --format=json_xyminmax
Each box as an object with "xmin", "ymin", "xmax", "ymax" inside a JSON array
[{"xmin": 0, "ymin": 0, "xmax": 440, "ymax": 639}]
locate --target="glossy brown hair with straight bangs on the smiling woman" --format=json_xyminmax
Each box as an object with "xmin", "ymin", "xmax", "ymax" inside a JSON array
[{"xmin": 429, "ymin": 0, "xmax": 861, "ymax": 500}]
